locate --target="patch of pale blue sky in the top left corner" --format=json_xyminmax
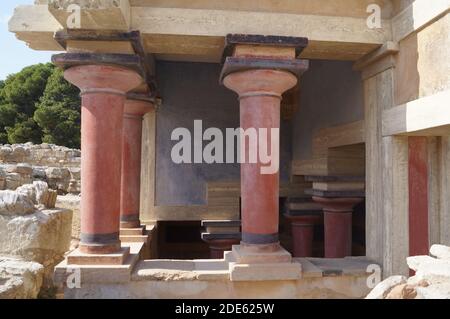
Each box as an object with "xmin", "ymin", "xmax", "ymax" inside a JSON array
[{"xmin": 0, "ymin": 0, "xmax": 55, "ymax": 80}]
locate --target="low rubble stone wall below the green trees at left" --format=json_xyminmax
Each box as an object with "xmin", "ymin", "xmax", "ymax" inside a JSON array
[{"xmin": 0, "ymin": 143, "xmax": 81, "ymax": 194}]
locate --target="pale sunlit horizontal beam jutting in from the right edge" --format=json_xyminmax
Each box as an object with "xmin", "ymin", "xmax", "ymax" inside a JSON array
[{"xmin": 382, "ymin": 90, "xmax": 450, "ymax": 136}]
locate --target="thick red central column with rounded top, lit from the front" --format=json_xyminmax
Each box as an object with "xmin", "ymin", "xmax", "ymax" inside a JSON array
[{"xmin": 223, "ymin": 69, "xmax": 297, "ymax": 250}]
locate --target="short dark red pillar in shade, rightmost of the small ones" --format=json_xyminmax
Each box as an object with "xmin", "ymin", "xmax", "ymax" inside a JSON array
[{"xmin": 313, "ymin": 196, "xmax": 363, "ymax": 258}]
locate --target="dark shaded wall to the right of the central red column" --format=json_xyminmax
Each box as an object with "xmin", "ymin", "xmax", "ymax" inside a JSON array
[{"xmin": 292, "ymin": 60, "xmax": 364, "ymax": 160}]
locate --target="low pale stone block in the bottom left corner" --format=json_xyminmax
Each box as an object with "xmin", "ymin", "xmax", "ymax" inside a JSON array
[{"xmin": 0, "ymin": 257, "xmax": 44, "ymax": 299}]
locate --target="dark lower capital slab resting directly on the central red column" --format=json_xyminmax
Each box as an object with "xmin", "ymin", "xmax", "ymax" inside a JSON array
[{"xmin": 220, "ymin": 57, "xmax": 309, "ymax": 84}]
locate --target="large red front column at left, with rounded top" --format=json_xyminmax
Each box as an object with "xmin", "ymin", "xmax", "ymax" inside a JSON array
[{"xmin": 64, "ymin": 65, "xmax": 142, "ymax": 254}]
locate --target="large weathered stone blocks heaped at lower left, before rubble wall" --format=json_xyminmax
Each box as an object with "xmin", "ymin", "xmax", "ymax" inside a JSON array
[{"xmin": 0, "ymin": 181, "xmax": 72, "ymax": 299}]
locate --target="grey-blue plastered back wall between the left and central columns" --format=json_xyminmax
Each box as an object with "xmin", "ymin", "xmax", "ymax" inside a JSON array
[{"xmin": 155, "ymin": 62, "xmax": 291, "ymax": 206}]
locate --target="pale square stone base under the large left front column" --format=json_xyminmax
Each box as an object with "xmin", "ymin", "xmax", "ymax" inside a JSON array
[{"xmin": 67, "ymin": 247, "xmax": 130, "ymax": 265}]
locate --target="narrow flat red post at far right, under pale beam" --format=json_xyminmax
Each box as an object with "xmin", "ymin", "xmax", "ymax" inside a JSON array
[{"xmin": 408, "ymin": 136, "xmax": 429, "ymax": 256}]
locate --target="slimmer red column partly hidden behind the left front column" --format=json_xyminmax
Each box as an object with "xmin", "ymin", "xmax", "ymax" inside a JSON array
[{"xmin": 120, "ymin": 99, "xmax": 154, "ymax": 228}]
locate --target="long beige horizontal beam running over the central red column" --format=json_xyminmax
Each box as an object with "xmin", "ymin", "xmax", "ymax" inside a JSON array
[{"xmin": 131, "ymin": 7, "xmax": 391, "ymax": 61}]
